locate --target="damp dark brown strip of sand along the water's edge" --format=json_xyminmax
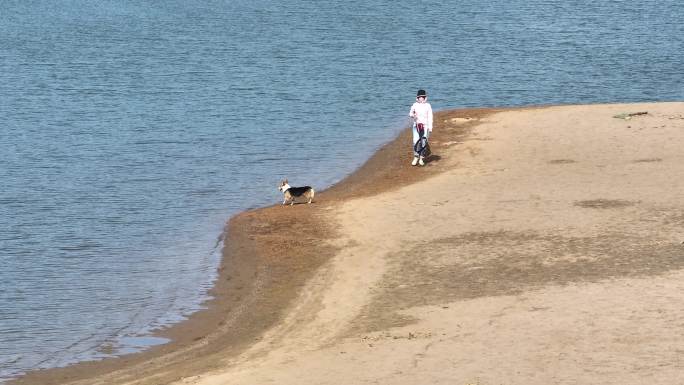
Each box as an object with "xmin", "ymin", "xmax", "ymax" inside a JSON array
[{"xmin": 11, "ymin": 109, "xmax": 503, "ymax": 385}]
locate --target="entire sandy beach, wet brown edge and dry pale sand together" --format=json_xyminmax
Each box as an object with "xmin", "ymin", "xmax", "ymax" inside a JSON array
[{"xmin": 12, "ymin": 102, "xmax": 684, "ymax": 385}]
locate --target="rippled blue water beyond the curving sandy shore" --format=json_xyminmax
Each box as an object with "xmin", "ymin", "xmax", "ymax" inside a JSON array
[{"xmin": 0, "ymin": 0, "xmax": 684, "ymax": 382}]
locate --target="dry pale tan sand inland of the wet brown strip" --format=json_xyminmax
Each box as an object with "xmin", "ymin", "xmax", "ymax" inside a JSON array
[{"xmin": 179, "ymin": 103, "xmax": 684, "ymax": 385}]
